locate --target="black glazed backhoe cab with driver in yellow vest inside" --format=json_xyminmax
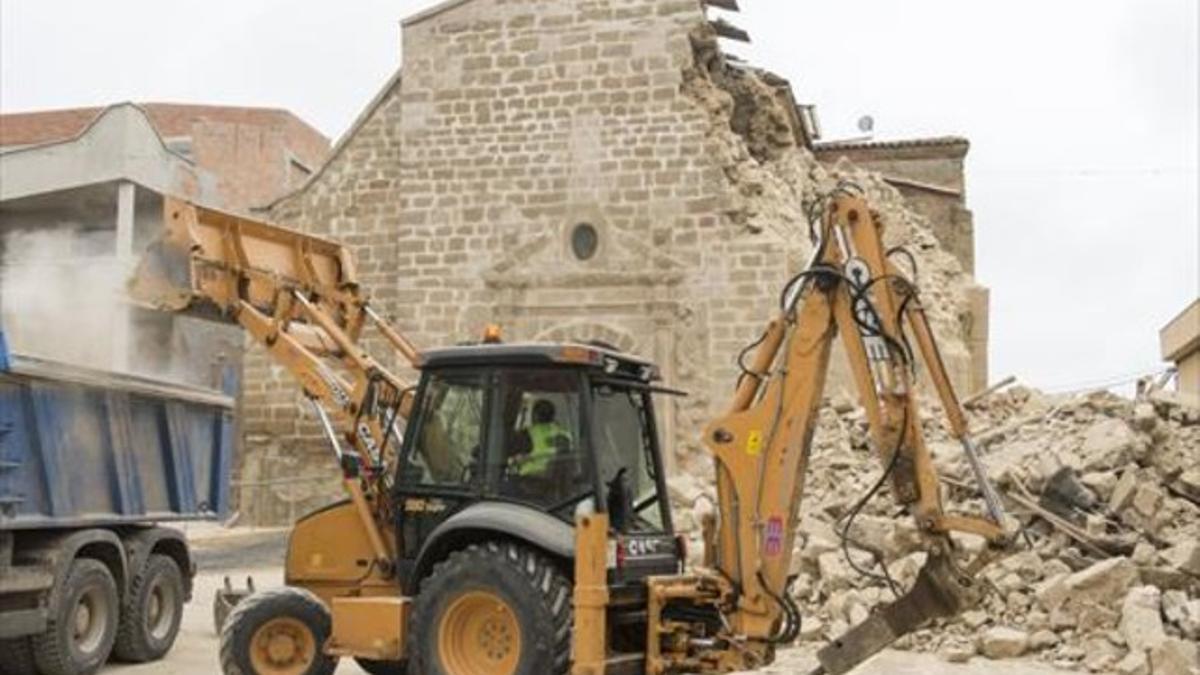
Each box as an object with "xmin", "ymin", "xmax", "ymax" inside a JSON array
[{"xmin": 395, "ymin": 344, "xmax": 682, "ymax": 586}]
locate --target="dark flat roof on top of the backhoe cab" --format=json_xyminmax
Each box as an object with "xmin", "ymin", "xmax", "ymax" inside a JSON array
[{"xmin": 421, "ymin": 342, "xmax": 660, "ymax": 382}]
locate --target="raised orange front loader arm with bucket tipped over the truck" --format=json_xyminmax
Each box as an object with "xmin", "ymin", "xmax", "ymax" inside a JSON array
[{"xmin": 130, "ymin": 197, "xmax": 420, "ymax": 569}]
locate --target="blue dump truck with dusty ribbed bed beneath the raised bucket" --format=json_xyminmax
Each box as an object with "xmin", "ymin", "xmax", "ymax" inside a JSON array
[{"xmin": 0, "ymin": 330, "xmax": 236, "ymax": 675}]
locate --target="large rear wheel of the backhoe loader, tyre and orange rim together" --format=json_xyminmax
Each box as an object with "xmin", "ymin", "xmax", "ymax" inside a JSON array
[{"xmin": 408, "ymin": 542, "xmax": 571, "ymax": 675}]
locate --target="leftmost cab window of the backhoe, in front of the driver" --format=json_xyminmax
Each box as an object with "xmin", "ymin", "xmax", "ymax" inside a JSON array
[{"xmin": 401, "ymin": 374, "xmax": 484, "ymax": 485}]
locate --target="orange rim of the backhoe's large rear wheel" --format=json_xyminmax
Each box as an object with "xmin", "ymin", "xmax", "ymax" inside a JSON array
[{"xmin": 438, "ymin": 591, "xmax": 521, "ymax": 675}]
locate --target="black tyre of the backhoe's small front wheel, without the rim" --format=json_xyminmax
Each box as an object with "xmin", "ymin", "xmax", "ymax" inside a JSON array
[{"xmin": 221, "ymin": 587, "xmax": 337, "ymax": 675}]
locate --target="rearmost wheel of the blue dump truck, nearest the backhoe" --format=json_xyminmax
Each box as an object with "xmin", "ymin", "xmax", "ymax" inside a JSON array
[{"xmin": 113, "ymin": 554, "xmax": 184, "ymax": 663}]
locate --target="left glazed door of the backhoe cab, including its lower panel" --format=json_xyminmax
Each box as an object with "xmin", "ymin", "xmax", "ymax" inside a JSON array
[{"xmin": 395, "ymin": 369, "xmax": 493, "ymax": 568}]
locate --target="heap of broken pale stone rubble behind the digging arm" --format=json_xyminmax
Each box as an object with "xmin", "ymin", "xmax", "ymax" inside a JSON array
[{"xmin": 672, "ymin": 387, "xmax": 1200, "ymax": 675}]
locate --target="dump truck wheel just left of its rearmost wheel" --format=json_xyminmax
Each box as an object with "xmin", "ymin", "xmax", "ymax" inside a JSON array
[{"xmin": 32, "ymin": 557, "xmax": 120, "ymax": 675}]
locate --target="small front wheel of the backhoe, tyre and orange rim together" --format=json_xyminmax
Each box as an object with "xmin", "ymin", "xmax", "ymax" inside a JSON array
[{"xmin": 221, "ymin": 587, "xmax": 337, "ymax": 675}]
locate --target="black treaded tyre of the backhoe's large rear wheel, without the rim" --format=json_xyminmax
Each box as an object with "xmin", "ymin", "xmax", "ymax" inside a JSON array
[{"xmin": 408, "ymin": 542, "xmax": 571, "ymax": 675}]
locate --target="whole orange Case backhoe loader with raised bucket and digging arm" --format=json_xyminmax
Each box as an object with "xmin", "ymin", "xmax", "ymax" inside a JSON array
[{"xmin": 132, "ymin": 185, "xmax": 1012, "ymax": 675}]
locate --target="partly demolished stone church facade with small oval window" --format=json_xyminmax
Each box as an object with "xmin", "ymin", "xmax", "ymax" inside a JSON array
[{"xmin": 241, "ymin": 0, "xmax": 988, "ymax": 519}]
